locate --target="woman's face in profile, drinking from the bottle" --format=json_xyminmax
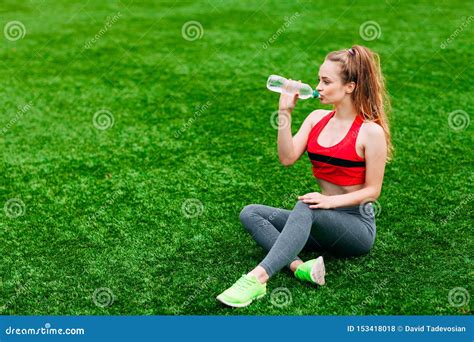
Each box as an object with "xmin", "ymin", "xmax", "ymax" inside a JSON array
[{"xmin": 316, "ymin": 60, "xmax": 352, "ymax": 104}]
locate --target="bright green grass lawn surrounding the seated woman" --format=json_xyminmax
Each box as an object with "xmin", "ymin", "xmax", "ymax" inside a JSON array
[{"xmin": 0, "ymin": 0, "xmax": 474, "ymax": 315}]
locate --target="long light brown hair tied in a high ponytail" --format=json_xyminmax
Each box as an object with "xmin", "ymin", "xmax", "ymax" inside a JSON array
[{"xmin": 326, "ymin": 45, "xmax": 393, "ymax": 161}]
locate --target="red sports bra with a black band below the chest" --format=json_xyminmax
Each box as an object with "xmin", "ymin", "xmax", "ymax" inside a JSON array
[{"xmin": 306, "ymin": 111, "xmax": 365, "ymax": 185}]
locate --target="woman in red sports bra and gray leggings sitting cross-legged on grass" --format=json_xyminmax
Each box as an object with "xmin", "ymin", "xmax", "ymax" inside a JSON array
[{"xmin": 217, "ymin": 45, "xmax": 392, "ymax": 307}]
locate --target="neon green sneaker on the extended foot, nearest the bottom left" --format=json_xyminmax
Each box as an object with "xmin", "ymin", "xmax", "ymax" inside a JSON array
[{"xmin": 216, "ymin": 274, "xmax": 267, "ymax": 308}]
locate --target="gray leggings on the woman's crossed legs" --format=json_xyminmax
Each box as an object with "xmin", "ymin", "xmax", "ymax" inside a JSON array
[{"xmin": 240, "ymin": 201, "xmax": 376, "ymax": 277}]
